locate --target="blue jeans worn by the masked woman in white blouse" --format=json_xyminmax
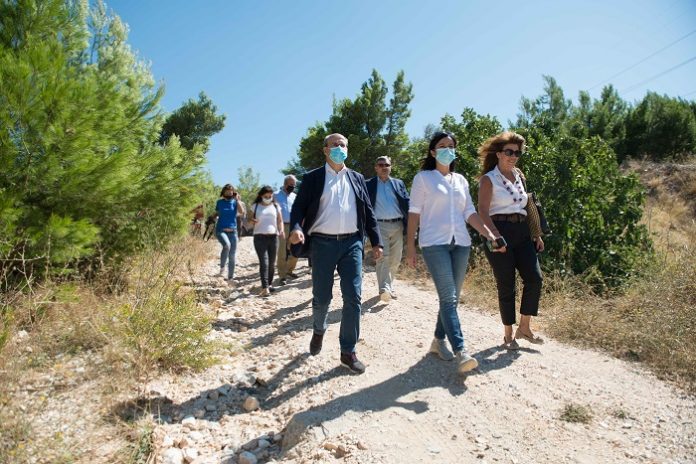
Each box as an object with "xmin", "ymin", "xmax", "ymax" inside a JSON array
[{"xmin": 423, "ymin": 244, "xmax": 471, "ymax": 352}]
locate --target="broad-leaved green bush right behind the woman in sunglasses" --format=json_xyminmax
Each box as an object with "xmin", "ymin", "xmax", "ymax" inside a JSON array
[{"xmin": 520, "ymin": 131, "xmax": 651, "ymax": 289}]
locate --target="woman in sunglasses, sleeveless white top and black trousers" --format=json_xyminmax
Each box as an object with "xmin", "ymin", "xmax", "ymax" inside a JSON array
[{"xmin": 478, "ymin": 132, "xmax": 544, "ymax": 350}]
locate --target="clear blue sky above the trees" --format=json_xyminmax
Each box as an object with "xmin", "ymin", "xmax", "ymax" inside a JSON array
[{"xmin": 107, "ymin": 0, "xmax": 696, "ymax": 185}]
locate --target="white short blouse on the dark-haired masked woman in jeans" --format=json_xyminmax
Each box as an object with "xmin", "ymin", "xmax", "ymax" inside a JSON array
[{"xmin": 408, "ymin": 169, "xmax": 476, "ymax": 248}]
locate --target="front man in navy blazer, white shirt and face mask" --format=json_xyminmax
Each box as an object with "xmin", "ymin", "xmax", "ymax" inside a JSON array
[{"xmin": 289, "ymin": 134, "xmax": 382, "ymax": 374}]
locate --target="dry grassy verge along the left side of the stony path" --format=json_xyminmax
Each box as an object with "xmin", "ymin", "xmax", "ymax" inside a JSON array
[{"xmin": 0, "ymin": 236, "xmax": 216, "ymax": 463}]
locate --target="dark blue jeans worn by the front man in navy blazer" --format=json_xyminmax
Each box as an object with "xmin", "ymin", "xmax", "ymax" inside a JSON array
[{"xmin": 310, "ymin": 233, "xmax": 363, "ymax": 353}]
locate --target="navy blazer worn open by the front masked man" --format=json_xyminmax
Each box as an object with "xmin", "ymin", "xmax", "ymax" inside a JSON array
[{"xmin": 290, "ymin": 165, "xmax": 383, "ymax": 256}]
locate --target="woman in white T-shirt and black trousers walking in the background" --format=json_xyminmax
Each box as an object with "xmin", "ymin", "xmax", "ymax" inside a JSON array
[{"xmin": 249, "ymin": 185, "xmax": 285, "ymax": 296}]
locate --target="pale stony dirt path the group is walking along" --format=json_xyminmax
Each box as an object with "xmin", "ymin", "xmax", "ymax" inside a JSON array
[{"xmin": 143, "ymin": 239, "xmax": 696, "ymax": 464}]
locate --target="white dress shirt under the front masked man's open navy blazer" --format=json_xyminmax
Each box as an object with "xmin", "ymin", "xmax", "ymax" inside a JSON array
[{"xmin": 309, "ymin": 163, "xmax": 358, "ymax": 235}]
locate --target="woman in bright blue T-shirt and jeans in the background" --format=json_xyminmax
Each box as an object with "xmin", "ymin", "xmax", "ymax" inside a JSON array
[{"xmin": 215, "ymin": 184, "xmax": 239, "ymax": 285}]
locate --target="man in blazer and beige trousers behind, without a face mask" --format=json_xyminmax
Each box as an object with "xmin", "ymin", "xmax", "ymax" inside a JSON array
[{"xmin": 367, "ymin": 156, "xmax": 409, "ymax": 303}]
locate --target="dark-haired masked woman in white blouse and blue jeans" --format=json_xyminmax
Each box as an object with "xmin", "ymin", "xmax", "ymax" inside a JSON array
[{"xmin": 406, "ymin": 132, "xmax": 505, "ymax": 373}]
